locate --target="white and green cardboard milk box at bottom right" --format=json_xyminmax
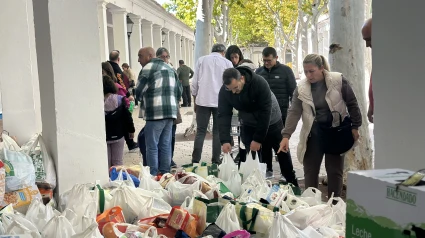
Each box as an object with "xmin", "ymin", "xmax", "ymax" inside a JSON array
[{"xmin": 345, "ymin": 169, "xmax": 425, "ymax": 238}]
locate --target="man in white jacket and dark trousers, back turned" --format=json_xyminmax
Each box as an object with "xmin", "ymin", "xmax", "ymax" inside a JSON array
[{"xmin": 191, "ymin": 44, "xmax": 233, "ymax": 164}]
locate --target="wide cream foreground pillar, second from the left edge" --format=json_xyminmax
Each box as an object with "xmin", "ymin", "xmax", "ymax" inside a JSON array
[{"xmin": 33, "ymin": 0, "xmax": 108, "ymax": 194}]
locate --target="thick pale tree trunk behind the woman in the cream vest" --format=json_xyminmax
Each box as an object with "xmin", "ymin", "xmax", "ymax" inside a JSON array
[{"xmin": 329, "ymin": 0, "xmax": 372, "ymax": 181}]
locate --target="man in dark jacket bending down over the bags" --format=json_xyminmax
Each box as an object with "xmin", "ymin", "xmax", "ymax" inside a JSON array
[{"xmin": 218, "ymin": 65, "xmax": 298, "ymax": 186}]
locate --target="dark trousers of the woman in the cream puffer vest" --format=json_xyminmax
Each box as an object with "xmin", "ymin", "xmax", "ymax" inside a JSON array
[{"xmin": 303, "ymin": 123, "xmax": 344, "ymax": 197}]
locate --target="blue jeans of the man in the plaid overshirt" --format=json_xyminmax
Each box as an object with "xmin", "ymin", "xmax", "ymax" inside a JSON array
[{"xmin": 145, "ymin": 119, "xmax": 174, "ymax": 176}]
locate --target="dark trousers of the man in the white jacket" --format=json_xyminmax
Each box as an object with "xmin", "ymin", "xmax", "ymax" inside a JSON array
[{"xmin": 192, "ymin": 106, "xmax": 221, "ymax": 163}]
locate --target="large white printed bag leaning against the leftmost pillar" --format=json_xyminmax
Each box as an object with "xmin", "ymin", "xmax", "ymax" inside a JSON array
[{"xmin": 2, "ymin": 133, "xmax": 35, "ymax": 192}]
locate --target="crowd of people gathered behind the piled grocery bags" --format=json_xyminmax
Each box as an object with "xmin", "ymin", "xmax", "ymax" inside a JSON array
[{"xmin": 102, "ymin": 19, "xmax": 373, "ymax": 196}]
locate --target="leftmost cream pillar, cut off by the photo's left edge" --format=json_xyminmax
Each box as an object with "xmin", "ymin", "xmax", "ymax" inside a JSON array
[{"xmin": 0, "ymin": 0, "xmax": 41, "ymax": 143}]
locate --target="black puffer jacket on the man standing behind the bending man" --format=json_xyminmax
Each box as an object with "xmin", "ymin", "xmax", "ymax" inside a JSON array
[{"xmin": 255, "ymin": 61, "xmax": 297, "ymax": 118}]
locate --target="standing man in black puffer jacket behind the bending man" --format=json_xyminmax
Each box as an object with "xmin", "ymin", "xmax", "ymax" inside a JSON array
[{"xmin": 256, "ymin": 47, "xmax": 297, "ymax": 178}]
